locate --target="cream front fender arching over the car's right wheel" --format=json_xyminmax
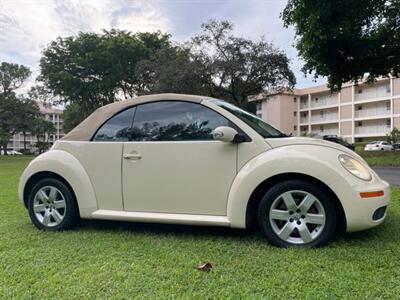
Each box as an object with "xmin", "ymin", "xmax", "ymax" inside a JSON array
[{"xmin": 227, "ymin": 145, "xmax": 343, "ymax": 228}]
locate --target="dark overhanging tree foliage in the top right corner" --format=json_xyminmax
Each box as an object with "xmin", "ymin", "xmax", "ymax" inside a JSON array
[{"xmin": 281, "ymin": 0, "xmax": 400, "ymax": 89}]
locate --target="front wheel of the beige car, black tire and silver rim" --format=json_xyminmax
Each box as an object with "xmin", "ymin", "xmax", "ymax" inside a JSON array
[{"xmin": 257, "ymin": 180, "xmax": 336, "ymax": 248}]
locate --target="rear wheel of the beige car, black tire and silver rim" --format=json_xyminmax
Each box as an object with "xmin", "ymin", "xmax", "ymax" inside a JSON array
[{"xmin": 28, "ymin": 178, "xmax": 79, "ymax": 231}]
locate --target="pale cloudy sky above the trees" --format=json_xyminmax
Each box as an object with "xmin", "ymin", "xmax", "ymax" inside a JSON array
[{"xmin": 0, "ymin": 0, "xmax": 325, "ymax": 92}]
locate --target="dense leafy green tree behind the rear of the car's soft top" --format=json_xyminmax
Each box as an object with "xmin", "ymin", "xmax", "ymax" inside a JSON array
[{"xmin": 39, "ymin": 30, "xmax": 170, "ymax": 119}]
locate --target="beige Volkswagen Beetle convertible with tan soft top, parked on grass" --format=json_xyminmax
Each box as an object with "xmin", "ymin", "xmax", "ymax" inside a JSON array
[{"xmin": 19, "ymin": 94, "xmax": 390, "ymax": 247}]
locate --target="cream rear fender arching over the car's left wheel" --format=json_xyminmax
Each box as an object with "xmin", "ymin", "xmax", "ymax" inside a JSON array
[{"xmin": 18, "ymin": 150, "xmax": 97, "ymax": 219}]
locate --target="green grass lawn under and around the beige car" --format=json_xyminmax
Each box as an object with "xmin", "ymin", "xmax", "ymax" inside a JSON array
[{"xmin": 0, "ymin": 157, "xmax": 400, "ymax": 299}]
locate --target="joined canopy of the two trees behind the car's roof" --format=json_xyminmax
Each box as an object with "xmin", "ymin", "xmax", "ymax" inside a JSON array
[{"xmin": 36, "ymin": 20, "xmax": 295, "ymax": 131}]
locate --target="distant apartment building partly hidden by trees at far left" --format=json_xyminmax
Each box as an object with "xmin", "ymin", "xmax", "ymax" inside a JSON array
[{"xmin": 7, "ymin": 101, "xmax": 64, "ymax": 151}]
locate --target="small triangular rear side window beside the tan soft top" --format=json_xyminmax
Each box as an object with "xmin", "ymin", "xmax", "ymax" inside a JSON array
[{"xmin": 93, "ymin": 107, "xmax": 136, "ymax": 142}]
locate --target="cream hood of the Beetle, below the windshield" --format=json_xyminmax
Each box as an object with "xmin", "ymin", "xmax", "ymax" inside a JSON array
[{"xmin": 265, "ymin": 137, "xmax": 360, "ymax": 158}]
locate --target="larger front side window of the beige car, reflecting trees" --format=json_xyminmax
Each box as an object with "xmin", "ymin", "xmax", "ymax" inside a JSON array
[{"xmin": 132, "ymin": 101, "xmax": 230, "ymax": 141}]
